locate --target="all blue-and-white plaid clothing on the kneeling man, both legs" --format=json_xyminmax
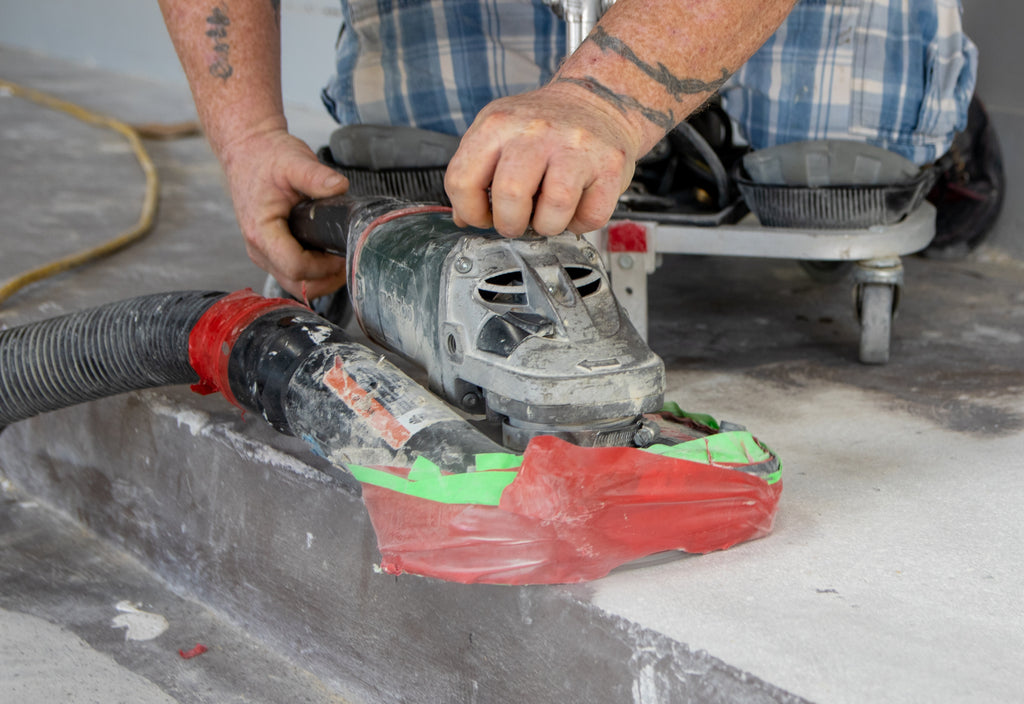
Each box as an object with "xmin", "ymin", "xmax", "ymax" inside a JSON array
[{"xmin": 324, "ymin": 0, "xmax": 977, "ymax": 164}]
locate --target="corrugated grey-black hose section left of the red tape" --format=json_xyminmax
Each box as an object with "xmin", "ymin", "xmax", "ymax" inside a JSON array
[{"xmin": 0, "ymin": 292, "xmax": 224, "ymax": 428}]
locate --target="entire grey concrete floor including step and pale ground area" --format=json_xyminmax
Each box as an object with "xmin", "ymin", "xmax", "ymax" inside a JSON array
[{"xmin": 0, "ymin": 48, "xmax": 1024, "ymax": 704}]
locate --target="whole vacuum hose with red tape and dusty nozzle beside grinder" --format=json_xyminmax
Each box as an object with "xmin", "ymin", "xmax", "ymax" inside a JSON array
[{"xmin": 0, "ymin": 291, "xmax": 504, "ymax": 472}]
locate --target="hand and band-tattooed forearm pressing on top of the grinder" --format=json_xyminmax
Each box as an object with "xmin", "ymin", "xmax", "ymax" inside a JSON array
[{"xmin": 444, "ymin": 0, "xmax": 794, "ymax": 237}]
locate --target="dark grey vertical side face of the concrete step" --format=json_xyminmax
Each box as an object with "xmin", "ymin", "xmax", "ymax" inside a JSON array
[{"xmin": 0, "ymin": 389, "xmax": 804, "ymax": 704}]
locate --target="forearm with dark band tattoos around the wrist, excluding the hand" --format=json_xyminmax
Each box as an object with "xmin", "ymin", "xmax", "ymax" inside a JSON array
[{"xmin": 552, "ymin": 0, "xmax": 795, "ymax": 153}]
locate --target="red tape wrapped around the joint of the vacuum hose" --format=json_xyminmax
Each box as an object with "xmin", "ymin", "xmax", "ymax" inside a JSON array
[{"xmin": 188, "ymin": 289, "xmax": 307, "ymax": 407}]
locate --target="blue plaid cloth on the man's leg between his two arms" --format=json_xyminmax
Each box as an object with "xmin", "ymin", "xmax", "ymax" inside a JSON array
[{"xmin": 323, "ymin": 0, "xmax": 565, "ymax": 135}]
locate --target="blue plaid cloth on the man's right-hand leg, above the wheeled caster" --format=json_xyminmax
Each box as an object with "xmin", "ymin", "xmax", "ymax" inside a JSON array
[{"xmin": 722, "ymin": 0, "xmax": 978, "ymax": 164}]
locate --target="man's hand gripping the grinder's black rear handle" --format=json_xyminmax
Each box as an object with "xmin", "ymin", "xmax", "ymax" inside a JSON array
[{"xmin": 223, "ymin": 124, "xmax": 348, "ymax": 299}]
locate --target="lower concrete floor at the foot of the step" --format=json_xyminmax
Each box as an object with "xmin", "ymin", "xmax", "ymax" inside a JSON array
[{"xmin": 0, "ymin": 472, "xmax": 350, "ymax": 704}]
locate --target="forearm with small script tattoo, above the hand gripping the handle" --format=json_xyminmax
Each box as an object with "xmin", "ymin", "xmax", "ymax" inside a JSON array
[{"xmin": 160, "ymin": 0, "xmax": 286, "ymax": 161}]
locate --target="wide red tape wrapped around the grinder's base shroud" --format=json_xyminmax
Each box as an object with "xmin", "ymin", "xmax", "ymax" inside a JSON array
[{"xmin": 362, "ymin": 436, "xmax": 782, "ymax": 584}]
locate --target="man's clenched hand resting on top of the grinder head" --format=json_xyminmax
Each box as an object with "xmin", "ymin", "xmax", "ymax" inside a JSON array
[{"xmin": 444, "ymin": 83, "xmax": 643, "ymax": 237}]
